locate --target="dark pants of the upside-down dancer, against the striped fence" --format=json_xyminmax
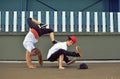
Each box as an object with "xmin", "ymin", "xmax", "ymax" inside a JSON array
[{"xmin": 27, "ymin": 18, "xmax": 53, "ymax": 36}]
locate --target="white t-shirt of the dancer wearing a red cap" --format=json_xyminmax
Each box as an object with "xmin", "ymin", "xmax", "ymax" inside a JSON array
[{"xmin": 47, "ymin": 42, "xmax": 67, "ymax": 59}]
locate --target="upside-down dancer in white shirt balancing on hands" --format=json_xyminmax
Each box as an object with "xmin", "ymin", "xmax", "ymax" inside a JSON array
[{"xmin": 23, "ymin": 18, "xmax": 56, "ymax": 68}]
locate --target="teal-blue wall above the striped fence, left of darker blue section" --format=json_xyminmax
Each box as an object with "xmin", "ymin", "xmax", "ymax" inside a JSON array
[{"xmin": 0, "ymin": 0, "xmax": 105, "ymax": 11}]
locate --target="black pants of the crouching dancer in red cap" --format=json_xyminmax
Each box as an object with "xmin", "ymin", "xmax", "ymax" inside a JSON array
[{"xmin": 48, "ymin": 49, "xmax": 80, "ymax": 63}]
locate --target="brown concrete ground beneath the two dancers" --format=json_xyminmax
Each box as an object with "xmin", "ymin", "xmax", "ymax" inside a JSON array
[{"xmin": 0, "ymin": 63, "xmax": 120, "ymax": 79}]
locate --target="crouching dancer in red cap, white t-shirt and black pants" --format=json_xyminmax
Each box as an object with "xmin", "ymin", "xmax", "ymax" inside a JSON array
[{"xmin": 47, "ymin": 36, "xmax": 82, "ymax": 69}]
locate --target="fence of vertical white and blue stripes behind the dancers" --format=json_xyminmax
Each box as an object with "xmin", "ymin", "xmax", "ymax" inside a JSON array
[{"xmin": 0, "ymin": 11, "xmax": 120, "ymax": 32}]
